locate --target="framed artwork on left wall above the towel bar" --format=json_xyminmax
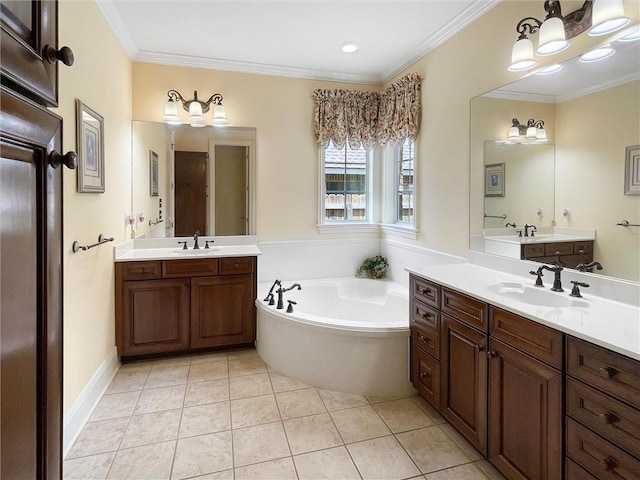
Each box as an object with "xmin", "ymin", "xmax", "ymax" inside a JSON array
[{"xmin": 76, "ymin": 99, "xmax": 104, "ymax": 193}]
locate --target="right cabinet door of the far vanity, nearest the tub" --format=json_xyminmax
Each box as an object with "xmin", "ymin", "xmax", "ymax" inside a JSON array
[{"xmin": 191, "ymin": 275, "xmax": 255, "ymax": 348}]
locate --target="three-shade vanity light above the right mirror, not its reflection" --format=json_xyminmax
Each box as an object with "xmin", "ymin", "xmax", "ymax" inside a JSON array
[{"xmin": 509, "ymin": 0, "xmax": 630, "ymax": 72}]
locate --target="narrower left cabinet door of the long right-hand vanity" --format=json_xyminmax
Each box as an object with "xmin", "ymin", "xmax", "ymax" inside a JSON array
[{"xmin": 440, "ymin": 314, "xmax": 487, "ymax": 454}]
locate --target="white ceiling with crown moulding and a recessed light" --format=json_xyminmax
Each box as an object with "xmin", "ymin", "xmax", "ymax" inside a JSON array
[{"xmin": 96, "ymin": 0, "xmax": 499, "ymax": 84}]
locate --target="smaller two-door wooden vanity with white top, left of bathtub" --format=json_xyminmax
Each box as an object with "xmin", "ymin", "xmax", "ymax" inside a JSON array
[{"xmin": 115, "ymin": 236, "xmax": 259, "ymax": 361}]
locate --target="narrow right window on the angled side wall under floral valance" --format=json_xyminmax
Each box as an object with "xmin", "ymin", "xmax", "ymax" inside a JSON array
[{"xmin": 394, "ymin": 139, "xmax": 415, "ymax": 225}]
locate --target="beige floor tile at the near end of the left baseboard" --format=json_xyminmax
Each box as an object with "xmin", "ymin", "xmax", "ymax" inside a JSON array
[{"xmin": 66, "ymin": 418, "xmax": 129, "ymax": 459}]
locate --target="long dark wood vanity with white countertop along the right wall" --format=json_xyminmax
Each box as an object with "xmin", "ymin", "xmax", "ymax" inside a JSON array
[{"xmin": 409, "ymin": 264, "xmax": 640, "ymax": 479}]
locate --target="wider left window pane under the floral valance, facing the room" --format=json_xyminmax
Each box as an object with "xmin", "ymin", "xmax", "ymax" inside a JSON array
[{"xmin": 322, "ymin": 143, "xmax": 371, "ymax": 224}]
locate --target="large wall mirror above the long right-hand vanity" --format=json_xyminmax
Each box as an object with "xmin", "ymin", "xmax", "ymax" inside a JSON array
[{"xmin": 469, "ymin": 41, "xmax": 640, "ymax": 281}]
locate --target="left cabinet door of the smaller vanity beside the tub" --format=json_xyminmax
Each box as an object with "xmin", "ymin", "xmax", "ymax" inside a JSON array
[{"xmin": 121, "ymin": 278, "xmax": 189, "ymax": 357}]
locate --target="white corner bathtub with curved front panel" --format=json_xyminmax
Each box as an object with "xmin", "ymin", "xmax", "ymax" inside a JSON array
[{"xmin": 256, "ymin": 278, "xmax": 415, "ymax": 396}]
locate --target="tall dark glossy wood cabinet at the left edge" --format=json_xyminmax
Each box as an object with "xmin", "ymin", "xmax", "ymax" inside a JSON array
[{"xmin": 0, "ymin": 1, "xmax": 76, "ymax": 479}]
